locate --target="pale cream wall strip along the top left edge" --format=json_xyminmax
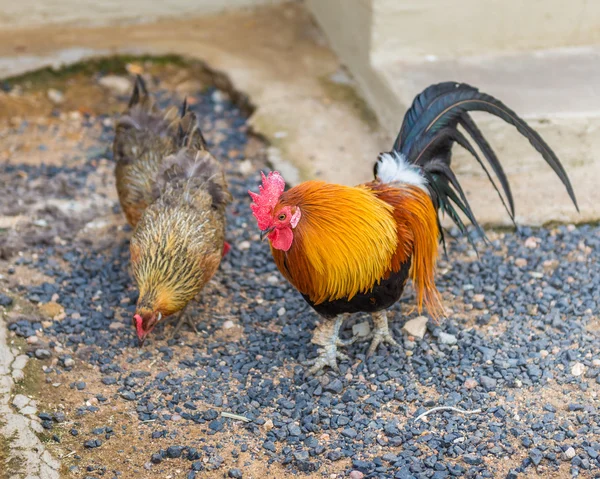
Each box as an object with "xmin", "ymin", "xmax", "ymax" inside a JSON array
[{"xmin": 0, "ymin": 0, "xmax": 283, "ymax": 29}]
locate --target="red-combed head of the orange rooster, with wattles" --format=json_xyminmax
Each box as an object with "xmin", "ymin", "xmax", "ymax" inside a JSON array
[{"xmin": 248, "ymin": 171, "xmax": 301, "ymax": 251}]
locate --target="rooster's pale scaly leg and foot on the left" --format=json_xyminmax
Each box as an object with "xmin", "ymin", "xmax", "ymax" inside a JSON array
[{"xmin": 307, "ymin": 316, "xmax": 358, "ymax": 375}]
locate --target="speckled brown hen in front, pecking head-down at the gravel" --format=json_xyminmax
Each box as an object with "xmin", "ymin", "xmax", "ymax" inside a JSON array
[{"xmin": 130, "ymin": 112, "xmax": 232, "ymax": 345}]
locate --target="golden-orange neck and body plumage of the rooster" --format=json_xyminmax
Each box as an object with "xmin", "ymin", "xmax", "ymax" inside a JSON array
[{"xmin": 271, "ymin": 181, "xmax": 442, "ymax": 317}]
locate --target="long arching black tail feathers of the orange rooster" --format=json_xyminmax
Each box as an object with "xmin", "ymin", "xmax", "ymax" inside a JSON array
[{"xmin": 393, "ymin": 82, "xmax": 579, "ymax": 244}]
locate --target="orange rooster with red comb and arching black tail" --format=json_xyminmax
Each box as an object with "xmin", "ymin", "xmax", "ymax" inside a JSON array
[{"xmin": 249, "ymin": 82, "xmax": 577, "ymax": 374}]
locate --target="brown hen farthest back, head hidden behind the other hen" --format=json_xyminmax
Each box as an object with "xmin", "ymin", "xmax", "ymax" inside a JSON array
[{"xmin": 113, "ymin": 75, "xmax": 206, "ymax": 227}]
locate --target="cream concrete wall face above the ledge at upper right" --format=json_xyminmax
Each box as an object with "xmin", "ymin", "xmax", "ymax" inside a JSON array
[{"xmin": 370, "ymin": 0, "xmax": 600, "ymax": 62}]
